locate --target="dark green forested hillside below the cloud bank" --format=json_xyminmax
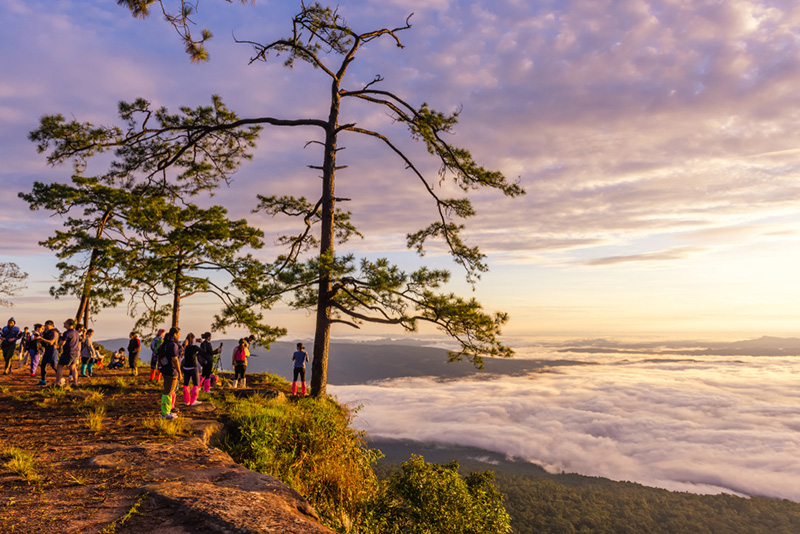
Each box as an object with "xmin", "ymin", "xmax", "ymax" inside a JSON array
[{"xmin": 372, "ymin": 440, "xmax": 800, "ymax": 534}]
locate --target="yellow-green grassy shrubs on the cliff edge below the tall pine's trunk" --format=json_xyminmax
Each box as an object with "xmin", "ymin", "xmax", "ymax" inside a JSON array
[{"xmin": 219, "ymin": 396, "xmax": 380, "ymax": 531}]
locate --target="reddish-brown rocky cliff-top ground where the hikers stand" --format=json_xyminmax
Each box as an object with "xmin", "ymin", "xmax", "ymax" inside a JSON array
[{"xmin": 0, "ymin": 361, "xmax": 332, "ymax": 534}]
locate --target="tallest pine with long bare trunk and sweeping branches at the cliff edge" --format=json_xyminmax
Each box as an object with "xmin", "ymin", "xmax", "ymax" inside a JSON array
[{"xmin": 31, "ymin": 0, "xmax": 524, "ymax": 395}]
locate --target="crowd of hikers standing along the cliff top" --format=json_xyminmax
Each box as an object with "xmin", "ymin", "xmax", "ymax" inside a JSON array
[{"xmin": 0, "ymin": 317, "xmax": 309, "ymax": 419}]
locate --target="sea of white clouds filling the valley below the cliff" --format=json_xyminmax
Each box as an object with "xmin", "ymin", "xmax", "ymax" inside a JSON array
[{"xmin": 328, "ymin": 351, "xmax": 800, "ymax": 502}]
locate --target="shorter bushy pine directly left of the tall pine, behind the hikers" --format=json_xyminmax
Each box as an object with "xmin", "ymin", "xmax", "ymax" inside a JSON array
[{"xmin": 126, "ymin": 204, "xmax": 285, "ymax": 344}]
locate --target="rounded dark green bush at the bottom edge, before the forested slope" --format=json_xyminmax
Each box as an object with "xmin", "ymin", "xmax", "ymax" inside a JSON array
[{"xmin": 371, "ymin": 455, "xmax": 511, "ymax": 534}]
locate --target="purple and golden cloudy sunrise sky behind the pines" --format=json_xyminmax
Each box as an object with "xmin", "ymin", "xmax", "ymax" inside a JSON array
[{"xmin": 0, "ymin": 0, "xmax": 800, "ymax": 339}]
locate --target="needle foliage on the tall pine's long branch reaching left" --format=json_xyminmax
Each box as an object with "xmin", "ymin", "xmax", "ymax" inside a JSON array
[{"xmin": 29, "ymin": 95, "xmax": 261, "ymax": 195}]
